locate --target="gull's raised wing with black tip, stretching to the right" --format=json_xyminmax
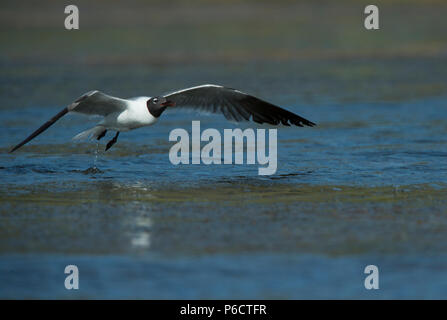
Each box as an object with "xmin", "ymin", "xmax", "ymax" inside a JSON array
[{"xmin": 164, "ymin": 84, "xmax": 315, "ymax": 127}]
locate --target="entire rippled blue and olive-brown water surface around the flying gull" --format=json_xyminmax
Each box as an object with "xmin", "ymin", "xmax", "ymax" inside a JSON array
[{"xmin": 0, "ymin": 0, "xmax": 447, "ymax": 299}]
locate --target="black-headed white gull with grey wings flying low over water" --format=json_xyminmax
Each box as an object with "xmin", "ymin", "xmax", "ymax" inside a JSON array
[{"xmin": 9, "ymin": 84, "xmax": 315, "ymax": 153}]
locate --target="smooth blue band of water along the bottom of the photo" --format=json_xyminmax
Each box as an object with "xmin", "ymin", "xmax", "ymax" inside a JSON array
[{"xmin": 0, "ymin": 254, "xmax": 447, "ymax": 299}]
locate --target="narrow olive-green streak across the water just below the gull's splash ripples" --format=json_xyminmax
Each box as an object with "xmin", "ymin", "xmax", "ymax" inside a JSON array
[{"xmin": 0, "ymin": 182, "xmax": 447, "ymax": 209}]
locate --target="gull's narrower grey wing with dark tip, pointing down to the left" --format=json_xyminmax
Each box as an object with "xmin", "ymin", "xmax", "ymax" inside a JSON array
[{"xmin": 9, "ymin": 90, "xmax": 126, "ymax": 153}]
